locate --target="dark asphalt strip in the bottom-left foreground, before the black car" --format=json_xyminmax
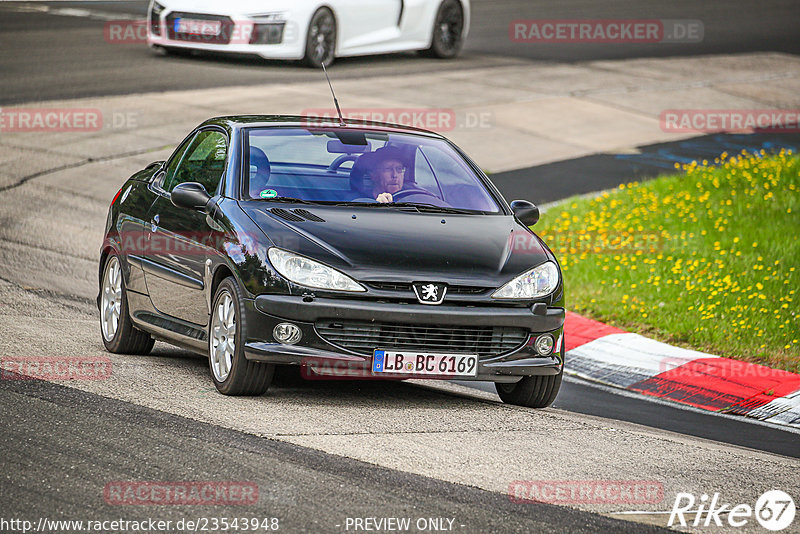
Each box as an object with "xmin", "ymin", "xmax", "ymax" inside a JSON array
[{"xmin": 0, "ymin": 380, "xmax": 666, "ymax": 533}]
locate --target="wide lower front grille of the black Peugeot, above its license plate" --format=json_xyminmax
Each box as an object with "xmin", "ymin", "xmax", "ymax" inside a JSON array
[{"xmin": 315, "ymin": 319, "xmax": 528, "ymax": 359}]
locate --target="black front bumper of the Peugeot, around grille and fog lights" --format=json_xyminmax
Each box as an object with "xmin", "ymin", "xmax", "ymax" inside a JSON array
[{"xmin": 245, "ymin": 295, "xmax": 565, "ymax": 382}]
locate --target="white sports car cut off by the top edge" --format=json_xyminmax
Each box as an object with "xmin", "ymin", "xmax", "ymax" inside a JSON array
[{"xmin": 147, "ymin": 0, "xmax": 470, "ymax": 67}]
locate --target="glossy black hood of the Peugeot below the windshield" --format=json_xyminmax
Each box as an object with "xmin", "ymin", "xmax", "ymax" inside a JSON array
[{"xmin": 243, "ymin": 205, "xmax": 550, "ymax": 287}]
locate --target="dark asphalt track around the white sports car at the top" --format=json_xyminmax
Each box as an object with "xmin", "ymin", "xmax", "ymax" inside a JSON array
[{"xmin": 0, "ymin": 0, "xmax": 800, "ymax": 105}]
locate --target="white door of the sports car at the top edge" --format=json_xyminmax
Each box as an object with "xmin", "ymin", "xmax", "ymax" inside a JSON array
[{"xmin": 335, "ymin": 0, "xmax": 403, "ymax": 55}]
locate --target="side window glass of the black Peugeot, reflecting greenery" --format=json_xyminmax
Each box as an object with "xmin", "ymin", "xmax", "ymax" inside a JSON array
[{"xmin": 164, "ymin": 130, "xmax": 228, "ymax": 195}]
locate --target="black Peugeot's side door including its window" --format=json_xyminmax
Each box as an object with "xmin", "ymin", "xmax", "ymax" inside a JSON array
[{"xmin": 142, "ymin": 128, "xmax": 228, "ymax": 326}]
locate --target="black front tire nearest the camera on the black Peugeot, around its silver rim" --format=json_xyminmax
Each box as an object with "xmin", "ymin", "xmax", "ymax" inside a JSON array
[{"xmin": 208, "ymin": 276, "xmax": 275, "ymax": 395}]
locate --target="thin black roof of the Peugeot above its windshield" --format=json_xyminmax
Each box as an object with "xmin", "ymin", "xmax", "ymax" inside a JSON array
[{"xmin": 202, "ymin": 115, "xmax": 444, "ymax": 139}]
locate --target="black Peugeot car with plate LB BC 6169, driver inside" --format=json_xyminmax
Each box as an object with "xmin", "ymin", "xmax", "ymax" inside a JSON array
[{"xmin": 97, "ymin": 116, "xmax": 565, "ymax": 407}]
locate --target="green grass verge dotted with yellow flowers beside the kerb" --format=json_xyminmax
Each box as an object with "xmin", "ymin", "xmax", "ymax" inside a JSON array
[{"xmin": 535, "ymin": 151, "xmax": 800, "ymax": 372}]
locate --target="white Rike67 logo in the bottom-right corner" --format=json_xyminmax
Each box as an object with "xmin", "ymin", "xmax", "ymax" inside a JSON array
[{"xmin": 667, "ymin": 490, "xmax": 797, "ymax": 532}]
